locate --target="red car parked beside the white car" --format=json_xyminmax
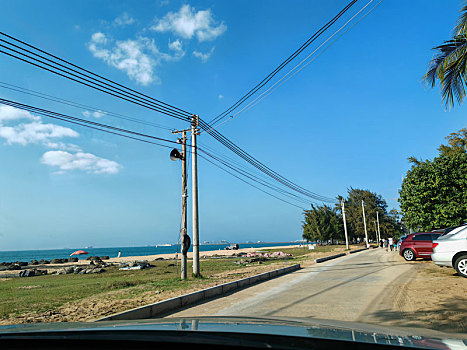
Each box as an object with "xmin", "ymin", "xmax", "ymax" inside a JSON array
[{"xmin": 399, "ymin": 232, "xmax": 441, "ymax": 261}]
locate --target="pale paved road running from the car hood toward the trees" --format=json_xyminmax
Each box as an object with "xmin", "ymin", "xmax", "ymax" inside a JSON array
[{"xmin": 168, "ymin": 249, "xmax": 413, "ymax": 322}]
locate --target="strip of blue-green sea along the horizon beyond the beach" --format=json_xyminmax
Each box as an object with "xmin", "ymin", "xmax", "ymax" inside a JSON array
[{"xmin": 0, "ymin": 242, "xmax": 299, "ymax": 262}]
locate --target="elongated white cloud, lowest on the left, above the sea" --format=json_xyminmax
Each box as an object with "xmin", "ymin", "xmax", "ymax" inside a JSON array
[{"xmin": 41, "ymin": 151, "xmax": 122, "ymax": 174}]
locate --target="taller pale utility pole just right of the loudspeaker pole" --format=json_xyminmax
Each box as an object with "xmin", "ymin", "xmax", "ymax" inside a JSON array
[{"xmin": 191, "ymin": 115, "xmax": 200, "ymax": 277}]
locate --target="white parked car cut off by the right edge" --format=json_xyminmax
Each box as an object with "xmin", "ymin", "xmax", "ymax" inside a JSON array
[{"xmin": 431, "ymin": 225, "xmax": 467, "ymax": 278}]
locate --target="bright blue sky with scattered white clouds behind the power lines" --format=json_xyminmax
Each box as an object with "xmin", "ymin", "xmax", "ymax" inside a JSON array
[{"xmin": 0, "ymin": 0, "xmax": 465, "ymax": 250}]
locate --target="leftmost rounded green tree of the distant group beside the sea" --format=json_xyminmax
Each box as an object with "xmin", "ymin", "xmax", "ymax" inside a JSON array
[{"xmin": 302, "ymin": 205, "xmax": 344, "ymax": 242}]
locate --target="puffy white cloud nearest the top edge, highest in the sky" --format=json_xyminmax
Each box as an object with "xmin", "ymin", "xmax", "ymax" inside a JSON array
[{"xmin": 150, "ymin": 5, "xmax": 227, "ymax": 42}]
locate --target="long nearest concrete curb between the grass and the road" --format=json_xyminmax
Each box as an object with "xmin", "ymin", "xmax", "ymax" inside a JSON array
[{"xmin": 96, "ymin": 264, "xmax": 300, "ymax": 322}]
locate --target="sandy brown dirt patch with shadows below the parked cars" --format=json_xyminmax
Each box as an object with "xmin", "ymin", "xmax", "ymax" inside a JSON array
[{"xmin": 372, "ymin": 260, "xmax": 467, "ymax": 333}]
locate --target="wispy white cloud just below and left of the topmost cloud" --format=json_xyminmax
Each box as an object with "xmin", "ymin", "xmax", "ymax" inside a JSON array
[{"xmin": 88, "ymin": 32, "xmax": 185, "ymax": 85}]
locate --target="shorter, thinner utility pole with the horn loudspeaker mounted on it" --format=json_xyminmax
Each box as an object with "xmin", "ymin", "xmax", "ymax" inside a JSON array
[{"xmin": 172, "ymin": 129, "xmax": 190, "ymax": 280}]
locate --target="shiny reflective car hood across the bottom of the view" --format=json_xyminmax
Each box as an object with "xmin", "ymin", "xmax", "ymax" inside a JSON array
[{"xmin": 0, "ymin": 317, "xmax": 467, "ymax": 349}]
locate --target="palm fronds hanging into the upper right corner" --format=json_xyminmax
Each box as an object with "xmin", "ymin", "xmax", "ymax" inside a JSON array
[{"xmin": 423, "ymin": 2, "xmax": 467, "ymax": 108}]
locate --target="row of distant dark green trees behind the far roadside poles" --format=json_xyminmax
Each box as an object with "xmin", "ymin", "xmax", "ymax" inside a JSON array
[{"xmin": 302, "ymin": 188, "xmax": 405, "ymax": 242}]
